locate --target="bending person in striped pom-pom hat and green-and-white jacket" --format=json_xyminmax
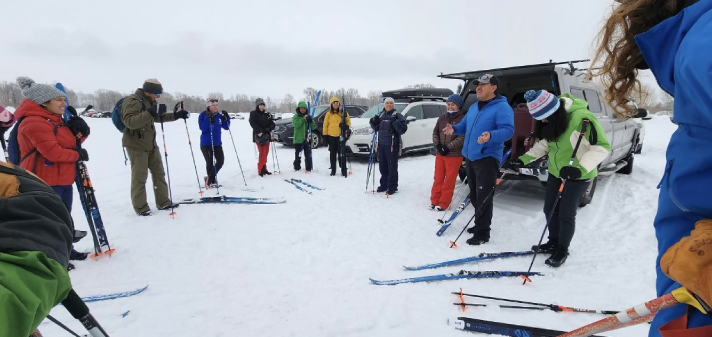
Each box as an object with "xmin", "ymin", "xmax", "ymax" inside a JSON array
[{"xmin": 511, "ymin": 90, "xmax": 611, "ymax": 267}]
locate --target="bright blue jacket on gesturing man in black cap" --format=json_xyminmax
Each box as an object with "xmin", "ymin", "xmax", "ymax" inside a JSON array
[{"xmin": 452, "ymin": 95, "xmax": 514, "ymax": 163}]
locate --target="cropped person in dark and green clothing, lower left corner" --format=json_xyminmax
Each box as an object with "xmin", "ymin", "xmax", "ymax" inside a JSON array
[{"xmin": 0, "ymin": 162, "xmax": 74, "ymax": 337}]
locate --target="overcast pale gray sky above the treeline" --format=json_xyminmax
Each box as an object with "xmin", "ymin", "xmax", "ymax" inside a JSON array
[{"xmin": 0, "ymin": 0, "xmax": 613, "ymax": 99}]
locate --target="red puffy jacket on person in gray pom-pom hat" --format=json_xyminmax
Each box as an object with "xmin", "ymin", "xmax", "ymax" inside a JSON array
[{"xmin": 15, "ymin": 99, "xmax": 79, "ymax": 186}]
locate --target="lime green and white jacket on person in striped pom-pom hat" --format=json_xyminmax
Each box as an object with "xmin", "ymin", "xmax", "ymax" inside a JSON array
[{"xmin": 519, "ymin": 94, "xmax": 611, "ymax": 180}]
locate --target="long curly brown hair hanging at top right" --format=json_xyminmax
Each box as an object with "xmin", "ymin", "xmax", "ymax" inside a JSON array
[{"xmin": 588, "ymin": 0, "xmax": 697, "ymax": 118}]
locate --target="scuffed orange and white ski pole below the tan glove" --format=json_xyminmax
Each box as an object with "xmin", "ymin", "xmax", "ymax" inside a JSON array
[{"xmin": 559, "ymin": 287, "xmax": 711, "ymax": 337}]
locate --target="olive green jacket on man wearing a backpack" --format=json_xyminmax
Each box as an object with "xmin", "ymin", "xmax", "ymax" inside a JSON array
[{"xmin": 121, "ymin": 89, "xmax": 175, "ymax": 151}]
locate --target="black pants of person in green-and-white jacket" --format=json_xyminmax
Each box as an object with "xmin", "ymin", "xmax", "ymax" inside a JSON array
[{"xmin": 544, "ymin": 174, "xmax": 590, "ymax": 248}]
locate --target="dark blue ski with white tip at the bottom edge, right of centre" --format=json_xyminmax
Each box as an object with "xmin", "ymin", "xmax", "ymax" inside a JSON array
[{"xmin": 448, "ymin": 317, "xmax": 601, "ymax": 337}]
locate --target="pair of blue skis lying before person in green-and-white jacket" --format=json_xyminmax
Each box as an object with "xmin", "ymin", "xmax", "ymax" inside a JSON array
[{"xmin": 370, "ymin": 251, "xmax": 544, "ymax": 285}]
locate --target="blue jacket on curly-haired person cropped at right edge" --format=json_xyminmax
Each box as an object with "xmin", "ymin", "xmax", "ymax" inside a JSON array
[{"xmin": 635, "ymin": 0, "xmax": 712, "ymax": 337}]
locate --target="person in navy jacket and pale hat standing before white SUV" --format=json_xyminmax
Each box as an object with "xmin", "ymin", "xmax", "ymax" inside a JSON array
[{"xmin": 369, "ymin": 97, "xmax": 408, "ymax": 195}]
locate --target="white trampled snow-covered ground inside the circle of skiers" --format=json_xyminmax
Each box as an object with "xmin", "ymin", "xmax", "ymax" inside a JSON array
[{"xmin": 40, "ymin": 115, "xmax": 676, "ymax": 337}]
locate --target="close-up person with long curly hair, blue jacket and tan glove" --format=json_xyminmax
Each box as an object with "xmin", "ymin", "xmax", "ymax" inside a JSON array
[{"xmin": 590, "ymin": 0, "xmax": 712, "ymax": 337}]
